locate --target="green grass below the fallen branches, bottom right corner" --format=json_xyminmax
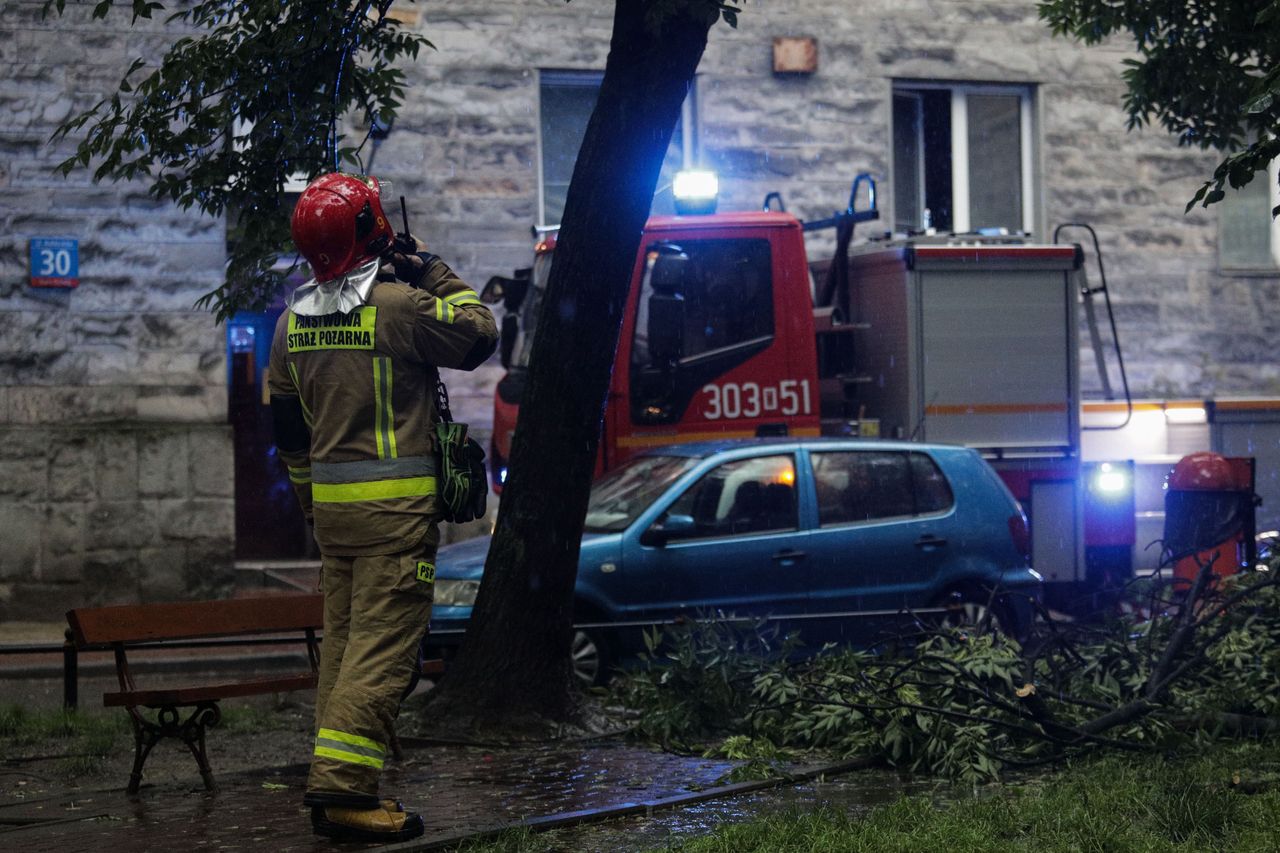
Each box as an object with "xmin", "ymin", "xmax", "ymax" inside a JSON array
[{"xmin": 461, "ymin": 743, "xmax": 1280, "ymax": 853}]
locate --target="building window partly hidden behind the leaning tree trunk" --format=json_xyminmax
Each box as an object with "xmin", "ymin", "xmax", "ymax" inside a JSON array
[{"xmin": 538, "ymin": 70, "xmax": 698, "ymax": 225}]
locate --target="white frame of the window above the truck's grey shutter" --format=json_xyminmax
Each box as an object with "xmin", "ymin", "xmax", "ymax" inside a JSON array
[{"xmin": 890, "ymin": 79, "xmax": 1039, "ymax": 234}]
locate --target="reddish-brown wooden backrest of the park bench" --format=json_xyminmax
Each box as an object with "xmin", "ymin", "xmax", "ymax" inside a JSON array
[{"xmin": 67, "ymin": 594, "xmax": 324, "ymax": 647}]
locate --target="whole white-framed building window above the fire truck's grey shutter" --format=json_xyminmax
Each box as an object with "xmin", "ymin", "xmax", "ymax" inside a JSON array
[{"xmin": 893, "ymin": 83, "xmax": 1036, "ymax": 233}]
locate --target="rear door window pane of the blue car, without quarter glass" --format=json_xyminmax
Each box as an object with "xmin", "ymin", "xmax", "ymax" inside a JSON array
[{"xmin": 810, "ymin": 451, "xmax": 916, "ymax": 526}]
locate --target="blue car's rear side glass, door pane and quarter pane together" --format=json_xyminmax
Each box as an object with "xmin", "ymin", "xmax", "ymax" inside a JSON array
[{"xmin": 810, "ymin": 451, "xmax": 954, "ymax": 526}]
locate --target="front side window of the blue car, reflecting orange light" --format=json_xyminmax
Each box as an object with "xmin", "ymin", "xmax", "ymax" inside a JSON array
[{"xmin": 667, "ymin": 455, "xmax": 799, "ymax": 539}]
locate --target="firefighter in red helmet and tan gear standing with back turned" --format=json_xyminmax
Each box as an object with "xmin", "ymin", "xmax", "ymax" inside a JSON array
[{"xmin": 268, "ymin": 173, "xmax": 498, "ymax": 841}]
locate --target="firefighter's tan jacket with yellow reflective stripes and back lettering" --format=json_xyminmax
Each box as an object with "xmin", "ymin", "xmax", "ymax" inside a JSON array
[{"xmin": 268, "ymin": 254, "xmax": 498, "ymax": 556}]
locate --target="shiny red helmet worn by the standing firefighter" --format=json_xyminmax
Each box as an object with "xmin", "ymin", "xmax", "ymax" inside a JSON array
[{"xmin": 289, "ymin": 172, "xmax": 394, "ymax": 282}]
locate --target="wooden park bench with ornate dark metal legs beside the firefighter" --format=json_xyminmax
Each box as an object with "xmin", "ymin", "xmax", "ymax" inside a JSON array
[{"xmin": 67, "ymin": 596, "xmax": 444, "ymax": 794}]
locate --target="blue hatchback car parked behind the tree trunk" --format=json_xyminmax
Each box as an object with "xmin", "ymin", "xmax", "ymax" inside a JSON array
[{"xmin": 430, "ymin": 438, "xmax": 1041, "ymax": 684}]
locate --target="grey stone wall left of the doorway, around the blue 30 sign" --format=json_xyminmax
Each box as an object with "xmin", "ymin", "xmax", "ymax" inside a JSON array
[{"xmin": 0, "ymin": 0, "xmax": 234, "ymax": 620}]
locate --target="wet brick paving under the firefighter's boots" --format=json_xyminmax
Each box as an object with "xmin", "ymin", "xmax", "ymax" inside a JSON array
[{"xmin": 0, "ymin": 740, "xmax": 855, "ymax": 853}]
